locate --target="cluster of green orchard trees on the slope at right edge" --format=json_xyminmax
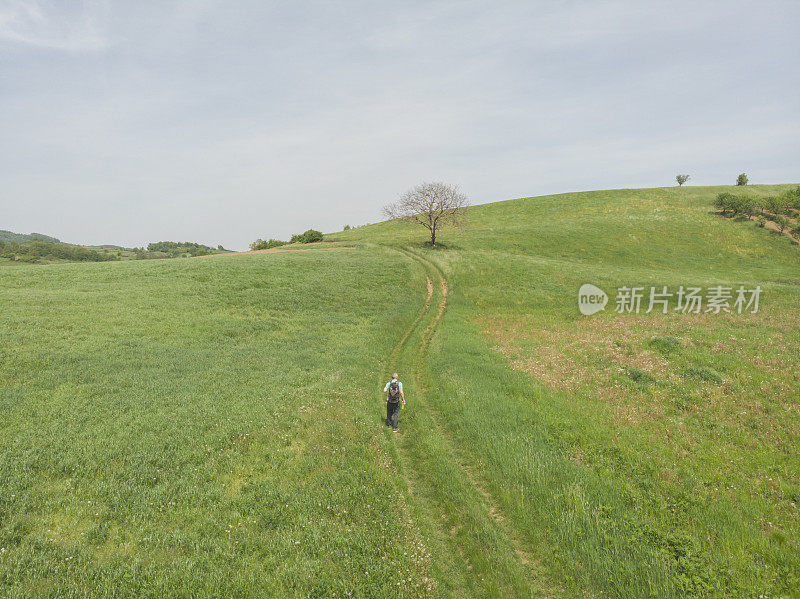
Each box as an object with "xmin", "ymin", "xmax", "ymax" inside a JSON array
[{"xmin": 714, "ymin": 187, "xmax": 800, "ymax": 237}]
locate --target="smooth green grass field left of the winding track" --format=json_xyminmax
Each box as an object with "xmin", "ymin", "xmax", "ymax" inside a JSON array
[{"xmin": 0, "ymin": 250, "xmax": 444, "ymax": 597}]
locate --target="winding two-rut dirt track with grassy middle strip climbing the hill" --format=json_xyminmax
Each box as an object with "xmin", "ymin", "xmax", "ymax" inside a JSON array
[{"xmin": 384, "ymin": 251, "xmax": 559, "ymax": 597}]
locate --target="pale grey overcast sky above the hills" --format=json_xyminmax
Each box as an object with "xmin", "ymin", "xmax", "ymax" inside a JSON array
[{"xmin": 0, "ymin": 0, "xmax": 800, "ymax": 249}]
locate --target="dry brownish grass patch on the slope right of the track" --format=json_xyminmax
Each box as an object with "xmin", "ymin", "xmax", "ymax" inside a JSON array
[{"xmin": 478, "ymin": 313, "xmax": 800, "ymax": 435}]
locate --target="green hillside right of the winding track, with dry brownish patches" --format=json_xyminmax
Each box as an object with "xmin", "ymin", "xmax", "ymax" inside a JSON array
[{"xmin": 329, "ymin": 186, "xmax": 800, "ymax": 597}]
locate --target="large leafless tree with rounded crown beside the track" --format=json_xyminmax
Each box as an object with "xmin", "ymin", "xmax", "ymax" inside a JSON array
[{"xmin": 383, "ymin": 182, "xmax": 469, "ymax": 247}]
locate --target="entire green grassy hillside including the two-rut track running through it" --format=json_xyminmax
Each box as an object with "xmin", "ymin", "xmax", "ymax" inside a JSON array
[{"xmin": 0, "ymin": 186, "xmax": 800, "ymax": 598}]
